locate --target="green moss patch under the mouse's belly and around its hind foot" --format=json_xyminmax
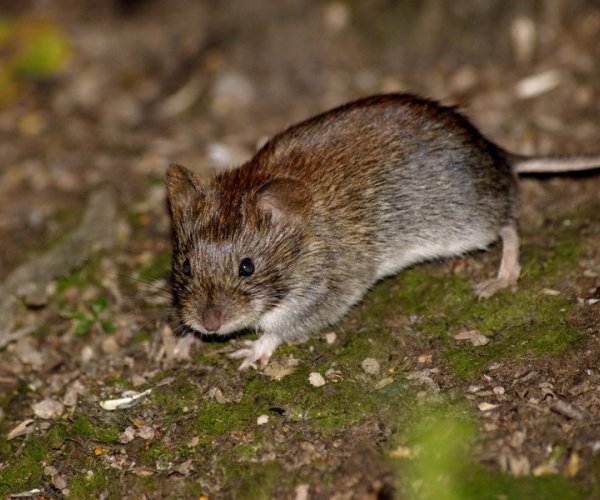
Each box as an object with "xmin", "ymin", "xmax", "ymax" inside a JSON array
[{"xmin": 360, "ymin": 207, "xmax": 582, "ymax": 377}]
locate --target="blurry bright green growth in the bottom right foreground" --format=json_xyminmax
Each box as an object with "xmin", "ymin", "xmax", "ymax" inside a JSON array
[{"xmin": 391, "ymin": 401, "xmax": 587, "ymax": 500}]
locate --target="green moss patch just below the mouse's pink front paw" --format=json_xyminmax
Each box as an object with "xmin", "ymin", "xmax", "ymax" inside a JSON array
[{"xmin": 183, "ymin": 332, "xmax": 392, "ymax": 453}]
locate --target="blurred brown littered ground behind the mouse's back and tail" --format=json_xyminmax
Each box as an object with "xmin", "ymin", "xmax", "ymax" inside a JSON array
[{"xmin": 0, "ymin": 0, "xmax": 600, "ymax": 276}]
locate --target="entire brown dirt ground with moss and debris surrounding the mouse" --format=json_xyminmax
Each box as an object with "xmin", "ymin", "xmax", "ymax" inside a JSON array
[{"xmin": 0, "ymin": 0, "xmax": 600, "ymax": 500}]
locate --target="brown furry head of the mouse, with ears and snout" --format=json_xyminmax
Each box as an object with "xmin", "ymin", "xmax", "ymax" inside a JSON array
[{"xmin": 166, "ymin": 165, "xmax": 311, "ymax": 335}]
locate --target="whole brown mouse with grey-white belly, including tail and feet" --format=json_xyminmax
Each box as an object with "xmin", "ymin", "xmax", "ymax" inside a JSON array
[{"xmin": 166, "ymin": 94, "xmax": 600, "ymax": 369}]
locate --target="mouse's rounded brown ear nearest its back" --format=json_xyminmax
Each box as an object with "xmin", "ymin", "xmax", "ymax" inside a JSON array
[{"xmin": 256, "ymin": 179, "xmax": 311, "ymax": 226}]
